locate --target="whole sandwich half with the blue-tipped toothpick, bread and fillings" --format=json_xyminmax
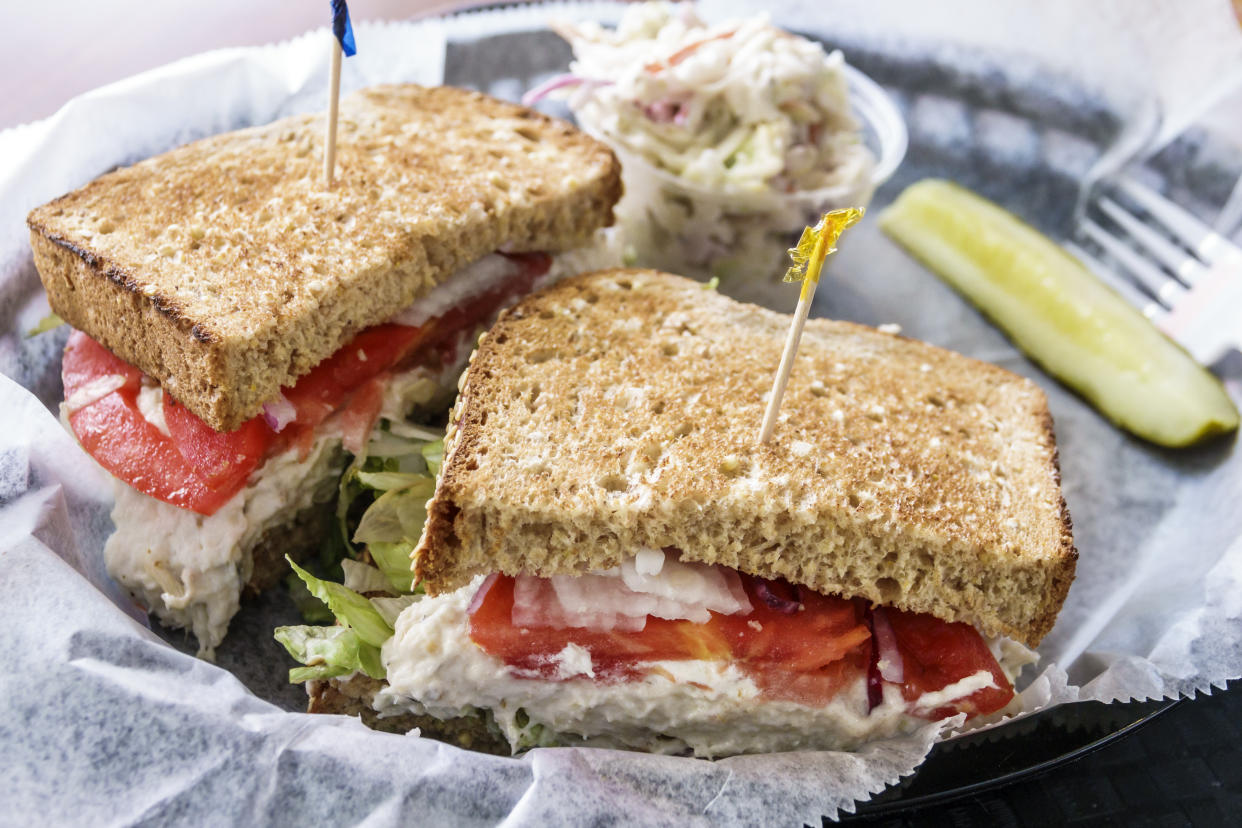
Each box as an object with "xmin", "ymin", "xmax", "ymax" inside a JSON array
[{"xmin": 27, "ymin": 86, "xmax": 620, "ymax": 655}]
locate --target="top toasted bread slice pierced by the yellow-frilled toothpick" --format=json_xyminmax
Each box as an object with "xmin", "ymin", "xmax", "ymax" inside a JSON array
[{"xmin": 415, "ymin": 271, "xmax": 1077, "ymax": 646}]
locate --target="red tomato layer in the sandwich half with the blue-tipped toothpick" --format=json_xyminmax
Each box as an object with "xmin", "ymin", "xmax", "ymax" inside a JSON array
[{"xmin": 62, "ymin": 253, "xmax": 551, "ymax": 515}]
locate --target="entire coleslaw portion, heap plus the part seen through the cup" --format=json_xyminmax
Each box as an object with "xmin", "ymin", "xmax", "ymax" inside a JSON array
[{"xmin": 523, "ymin": 2, "xmax": 874, "ymax": 285}]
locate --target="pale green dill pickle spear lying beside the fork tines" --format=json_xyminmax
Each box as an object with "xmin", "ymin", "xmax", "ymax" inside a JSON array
[{"xmin": 879, "ymin": 179, "xmax": 1238, "ymax": 447}]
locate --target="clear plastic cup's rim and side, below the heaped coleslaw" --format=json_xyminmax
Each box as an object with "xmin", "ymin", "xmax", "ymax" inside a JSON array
[{"xmin": 575, "ymin": 65, "xmax": 907, "ymax": 293}]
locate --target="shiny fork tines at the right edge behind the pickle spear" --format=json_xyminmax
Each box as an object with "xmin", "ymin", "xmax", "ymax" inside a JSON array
[{"xmin": 1066, "ymin": 174, "xmax": 1242, "ymax": 365}]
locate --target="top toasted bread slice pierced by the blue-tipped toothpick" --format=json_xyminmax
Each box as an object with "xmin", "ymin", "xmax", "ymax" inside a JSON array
[{"xmin": 27, "ymin": 86, "xmax": 621, "ymax": 430}]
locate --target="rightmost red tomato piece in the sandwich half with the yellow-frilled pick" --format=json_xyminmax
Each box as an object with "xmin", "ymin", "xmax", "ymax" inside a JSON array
[{"xmin": 887, "ymin": 610, "xmax": 1013, "ymax": 719}]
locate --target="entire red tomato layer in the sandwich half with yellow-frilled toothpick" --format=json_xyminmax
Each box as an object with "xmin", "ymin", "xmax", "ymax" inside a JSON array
[{"xmin": 469, "ymin": 575, "xmax": 1013, "ymax": 719}]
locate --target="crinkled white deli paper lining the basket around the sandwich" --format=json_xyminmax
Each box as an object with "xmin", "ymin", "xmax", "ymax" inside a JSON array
[{"xmin": 0, "ymin": 7, "xmax": 1242, "ymax": 824}]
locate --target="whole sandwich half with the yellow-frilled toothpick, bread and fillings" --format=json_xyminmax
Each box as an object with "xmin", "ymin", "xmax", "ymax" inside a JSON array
[{"xmin": 282, "ymin": 269, "xmax": 1077, "ymax": 756}]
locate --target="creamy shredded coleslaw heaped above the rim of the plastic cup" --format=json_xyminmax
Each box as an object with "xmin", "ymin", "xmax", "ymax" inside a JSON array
[{"xmin": 524, "ymin": 2, "xmax": 866, "ymax": 192}]
